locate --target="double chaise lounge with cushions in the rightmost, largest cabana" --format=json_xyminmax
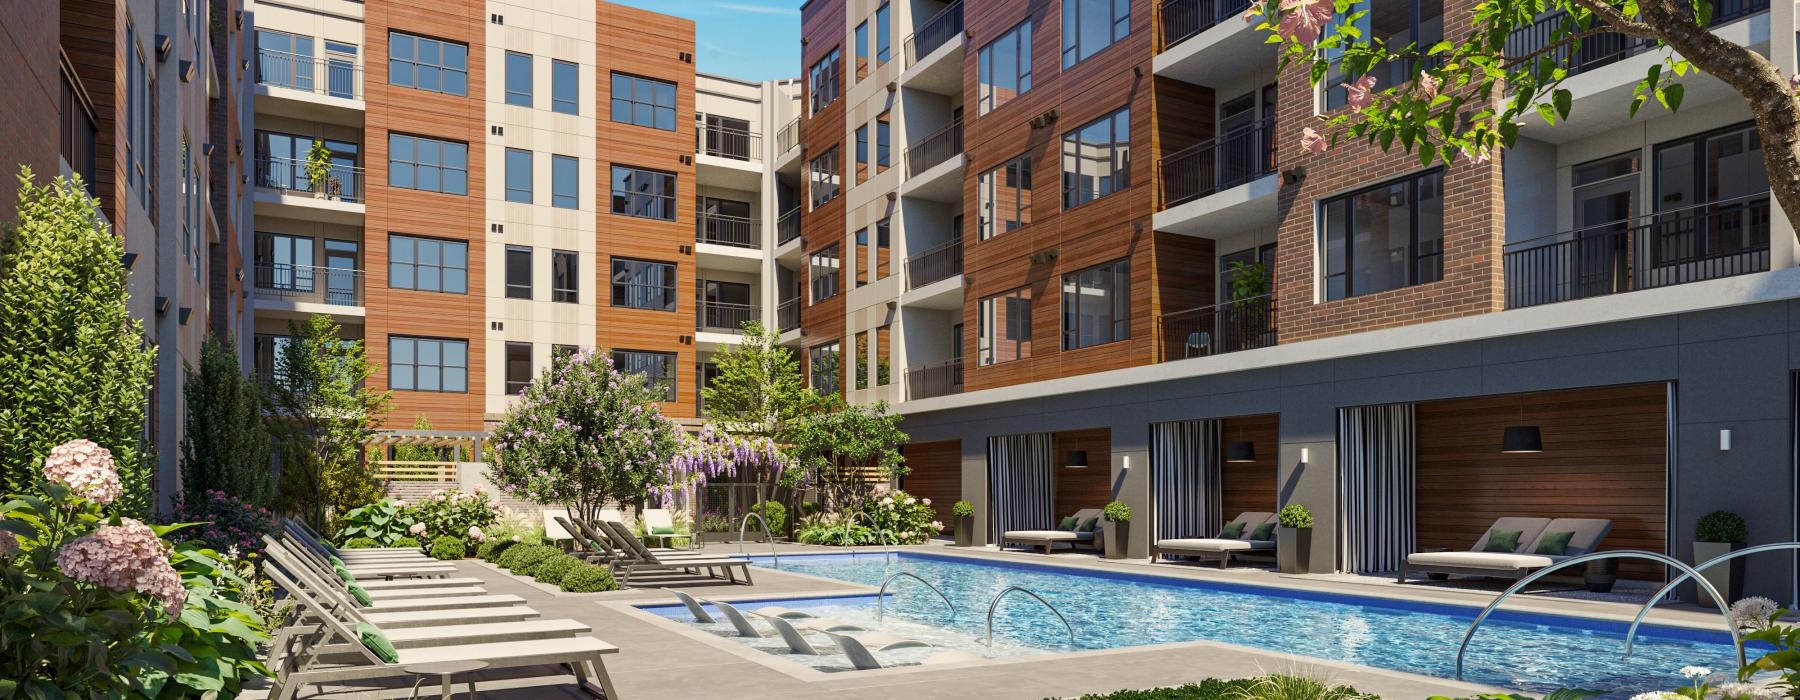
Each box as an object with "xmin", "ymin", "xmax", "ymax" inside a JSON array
[{"xmin": 1399, "ymin": 518, "xmax": 1613, "ymax": 583}]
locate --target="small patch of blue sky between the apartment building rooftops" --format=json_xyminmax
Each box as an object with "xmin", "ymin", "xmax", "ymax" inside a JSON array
[{"xmin": 616, "ymin": 0, "xmax": 801, "ymax": 81}]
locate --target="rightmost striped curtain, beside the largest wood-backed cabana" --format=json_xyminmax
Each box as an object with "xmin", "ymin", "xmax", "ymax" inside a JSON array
[{"xmin": 1337, "ymin": 403, "xmax": 1418, "ymax": 574}]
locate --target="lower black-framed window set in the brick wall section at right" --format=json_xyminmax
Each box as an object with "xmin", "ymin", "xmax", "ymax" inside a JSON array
[{"xmin": 1319, "ymin": 171, "xmax": 1444, "ymax": 299}]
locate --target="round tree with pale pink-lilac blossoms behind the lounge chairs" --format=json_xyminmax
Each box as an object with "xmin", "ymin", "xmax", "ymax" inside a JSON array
[{"xmin": 490, "ymin": 351, "xmax": 682, "ymax": 518}]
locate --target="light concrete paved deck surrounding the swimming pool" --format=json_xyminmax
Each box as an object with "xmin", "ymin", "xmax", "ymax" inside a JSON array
[{"xmin": 261, "ymin": 543, "xmax": 1721, "ymax": 700}]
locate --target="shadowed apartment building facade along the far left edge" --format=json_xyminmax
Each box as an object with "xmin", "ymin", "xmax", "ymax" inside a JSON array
[{"xmin": 0, "ymin": 0, "xmax": 250, "ymax": 506}]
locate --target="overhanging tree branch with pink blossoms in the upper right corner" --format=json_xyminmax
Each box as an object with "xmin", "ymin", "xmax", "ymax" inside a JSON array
[{"xmin": 1244, "ymin": 0, "xmax": 1800, "ymax": 229}]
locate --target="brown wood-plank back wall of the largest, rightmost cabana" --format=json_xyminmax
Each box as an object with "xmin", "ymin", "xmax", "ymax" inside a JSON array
[{"xmin": 1417, "ymin": 383, "xmax": 1669, "ymax": 579}]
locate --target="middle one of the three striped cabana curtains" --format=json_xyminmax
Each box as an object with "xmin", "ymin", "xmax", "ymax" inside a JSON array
[{"xmin": 1150, "ymin": 421, "xmax": 1224, "ymax": 542}]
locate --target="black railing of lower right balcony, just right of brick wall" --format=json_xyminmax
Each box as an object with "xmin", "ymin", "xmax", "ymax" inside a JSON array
[{"xmin": 1505, "ymin": 193, "xmax": 1769, "ymax": 308}]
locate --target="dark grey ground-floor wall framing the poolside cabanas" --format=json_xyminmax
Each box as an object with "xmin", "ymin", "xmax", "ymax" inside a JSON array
[{"xmin": 904, "ymin": 301, "xmax": 1800, "ymax": 601}]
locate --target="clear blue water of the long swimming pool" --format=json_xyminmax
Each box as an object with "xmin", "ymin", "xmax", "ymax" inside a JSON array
[{"xmin": 655, "ymin": 552, "xmax": 1735, "ymax": 693}]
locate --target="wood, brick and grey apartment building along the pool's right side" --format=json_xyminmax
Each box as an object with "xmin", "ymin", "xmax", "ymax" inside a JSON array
[{"xmin": 801, "ymin": 0, "xmax": 1800, "ymax": 599}]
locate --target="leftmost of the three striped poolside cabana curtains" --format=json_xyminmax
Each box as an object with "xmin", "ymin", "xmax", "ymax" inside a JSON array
[{"xmin": 988, "ymin": 432, "xmax": 1057, "ymax": 542}]
